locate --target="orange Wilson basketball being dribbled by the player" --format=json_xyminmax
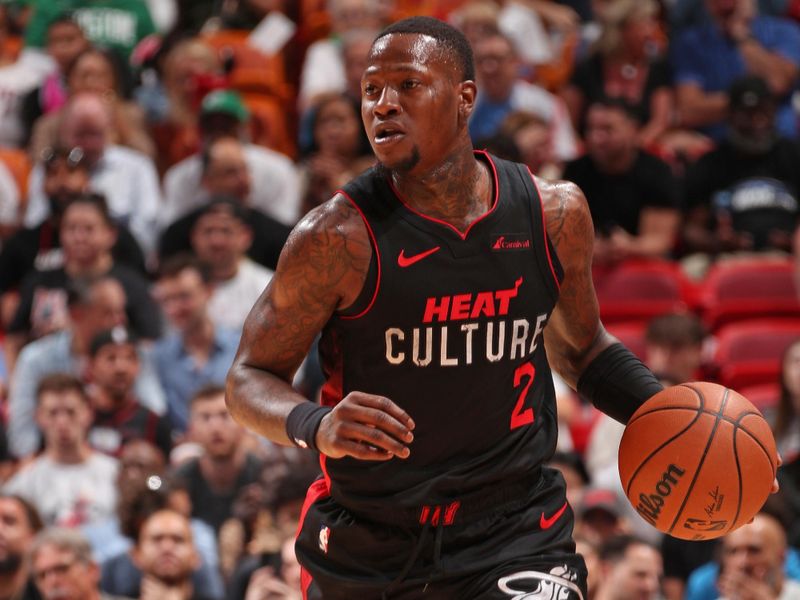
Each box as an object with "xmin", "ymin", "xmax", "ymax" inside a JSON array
[{"xmin": 619, "ymin": 382, "xmax": 778, "ymax": 540}]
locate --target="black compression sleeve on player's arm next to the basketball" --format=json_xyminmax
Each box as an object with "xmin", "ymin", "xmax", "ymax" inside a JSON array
[{"xmin": 578, "ymin": 344, "xmax": 664, "ymax": 424}]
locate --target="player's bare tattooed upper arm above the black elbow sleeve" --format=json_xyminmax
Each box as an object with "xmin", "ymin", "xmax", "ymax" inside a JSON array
[{"xmin": 536, "ymin": 179, "xmax": 617, "ymax": 388}]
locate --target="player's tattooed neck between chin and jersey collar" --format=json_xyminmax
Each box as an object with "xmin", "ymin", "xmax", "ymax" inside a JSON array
[{"xmin": 392, "ymin": 145, "xmax": 494, "ymax": 231}]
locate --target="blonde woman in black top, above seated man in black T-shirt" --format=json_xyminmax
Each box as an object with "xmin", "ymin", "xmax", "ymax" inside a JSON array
[{"xmin": 563, "ymin": 0, "xmax": 674, "ymax": 148}]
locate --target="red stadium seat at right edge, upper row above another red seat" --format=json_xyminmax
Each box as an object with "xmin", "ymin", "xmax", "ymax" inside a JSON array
[{"xmin": 700, "ymin": 258, "xmax": 800, "ymax": 331}]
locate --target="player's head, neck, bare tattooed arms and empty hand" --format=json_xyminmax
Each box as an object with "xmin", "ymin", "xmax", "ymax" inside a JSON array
[{"xmin": 226, "ymin": 34, "xmax": 615, "ymax": 460}]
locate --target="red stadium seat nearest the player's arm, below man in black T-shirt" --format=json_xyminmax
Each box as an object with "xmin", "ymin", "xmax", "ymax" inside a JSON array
[{"xmin": 597, "ymin": 261, "xmax": 692, "ymax": 323}]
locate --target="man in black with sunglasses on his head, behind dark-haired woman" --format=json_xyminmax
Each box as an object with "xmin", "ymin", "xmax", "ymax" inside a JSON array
[{"xmin": 0, "ymin": 146, "xmax": 145, "ymax": 314}]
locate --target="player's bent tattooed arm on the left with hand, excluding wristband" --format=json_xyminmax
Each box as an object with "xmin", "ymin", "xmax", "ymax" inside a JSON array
[{"xmin": 226, "ymin": 195, "xmax": 413, "ymax": 460}]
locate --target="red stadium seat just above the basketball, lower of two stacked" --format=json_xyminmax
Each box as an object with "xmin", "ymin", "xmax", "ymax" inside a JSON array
[{"xmin": 713, "ymin": 318, "xmax": 800, "ymax": 390}]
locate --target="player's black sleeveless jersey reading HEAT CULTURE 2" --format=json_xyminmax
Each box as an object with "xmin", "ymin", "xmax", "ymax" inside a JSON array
[{"xmin": 320, "ymin": 152, "xmax": 560, "ymax": 511}]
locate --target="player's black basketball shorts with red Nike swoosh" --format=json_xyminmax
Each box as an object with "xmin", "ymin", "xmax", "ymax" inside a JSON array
[{"xmin": 295, "ymin": 468, "xmax": 587, "ymax": 600}]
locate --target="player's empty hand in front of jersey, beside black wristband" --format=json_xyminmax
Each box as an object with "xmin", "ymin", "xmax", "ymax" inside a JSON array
[{"xmin": 316, "ymin": 392, "xmax": 414, "ymax": 460}]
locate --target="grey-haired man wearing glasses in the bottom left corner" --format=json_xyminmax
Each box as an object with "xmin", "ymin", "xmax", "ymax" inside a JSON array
[{"xmin": 29, "ymin": 528, "xmax": 124, "ymax": 600}]
